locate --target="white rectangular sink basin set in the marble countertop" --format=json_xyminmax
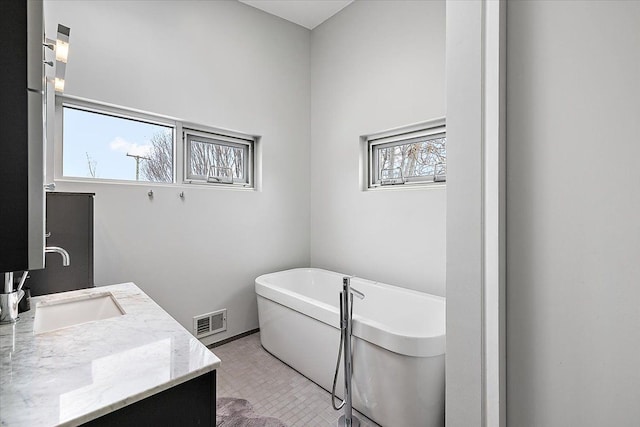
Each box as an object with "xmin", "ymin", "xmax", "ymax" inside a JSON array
[{"xmin": 33, "ymin": 292, "xmax": 124, "ymax": 334}]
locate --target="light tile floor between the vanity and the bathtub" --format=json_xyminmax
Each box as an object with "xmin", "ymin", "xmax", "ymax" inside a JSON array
[{"xmin": 212, "ymin": 333, "xmax": 379, "ymax": 427}]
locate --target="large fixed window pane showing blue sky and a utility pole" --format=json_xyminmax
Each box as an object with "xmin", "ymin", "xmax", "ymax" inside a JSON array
[{"xmin": 62, "ymin": 105, "xmax": 175, "ymax": 182}]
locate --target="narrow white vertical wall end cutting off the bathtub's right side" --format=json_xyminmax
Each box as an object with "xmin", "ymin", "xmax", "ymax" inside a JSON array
[{"xmin": 445, "ymin": 0, "xmax": 484, "ymax": 427}]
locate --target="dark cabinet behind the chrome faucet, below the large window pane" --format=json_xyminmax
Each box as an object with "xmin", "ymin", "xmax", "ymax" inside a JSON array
[{"xmin": 26, "ymin": 192, "xmax": 95, "ymax": 296}]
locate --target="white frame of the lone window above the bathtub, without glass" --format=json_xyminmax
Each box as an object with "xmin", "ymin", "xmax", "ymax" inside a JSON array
[{"xmin": 361, "ymin": 118, "xmax": 447, "ymax": 189}]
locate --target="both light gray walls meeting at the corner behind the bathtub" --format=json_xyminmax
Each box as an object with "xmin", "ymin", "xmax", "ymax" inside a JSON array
[{"xmin": 45, "ymin": 1, "xmax": 446, "ymax": 342}]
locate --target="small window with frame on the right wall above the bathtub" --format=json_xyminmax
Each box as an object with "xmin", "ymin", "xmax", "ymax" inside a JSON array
[{"xmin": 364, "ymin": 120, "xmax": 447, "ymax": 188}]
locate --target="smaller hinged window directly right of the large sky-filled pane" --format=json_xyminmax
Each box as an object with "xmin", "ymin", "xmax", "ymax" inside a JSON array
[{"xmin": 185, "ymin": 130, "xmax": 254, "ymax": 187}]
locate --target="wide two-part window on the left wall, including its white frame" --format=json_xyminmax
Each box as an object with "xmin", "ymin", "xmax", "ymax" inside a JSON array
[{"xmin": 55, "ymin": 96, "xmax": 258, "ymax": 188}]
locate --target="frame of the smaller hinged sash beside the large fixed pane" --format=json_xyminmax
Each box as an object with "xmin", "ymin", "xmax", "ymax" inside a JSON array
[{"xmin": 182, "ymin": 129, "xmax": 256, "ymax": 188}]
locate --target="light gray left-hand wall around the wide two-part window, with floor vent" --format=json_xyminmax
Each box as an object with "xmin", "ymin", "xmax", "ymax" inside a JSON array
[{"xmin": 45, "ymin": 0, "xmax": 310, "ymax": 342}]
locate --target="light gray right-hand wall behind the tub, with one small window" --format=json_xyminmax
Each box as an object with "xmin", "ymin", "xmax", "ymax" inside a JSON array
[{"xmin": 310, "ymin": 1, "xmax": 446, "ymax": 295}]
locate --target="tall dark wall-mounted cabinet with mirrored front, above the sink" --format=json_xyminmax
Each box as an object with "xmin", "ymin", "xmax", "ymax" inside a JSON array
[{"xmin": 0, "ymin": 0, "xmax": 45, "ymax": 272}]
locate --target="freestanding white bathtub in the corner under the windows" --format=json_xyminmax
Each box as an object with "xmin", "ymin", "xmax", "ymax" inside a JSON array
[{"xmin": 255, "ymin": 268, "xmax": 445, "ymax": 427}]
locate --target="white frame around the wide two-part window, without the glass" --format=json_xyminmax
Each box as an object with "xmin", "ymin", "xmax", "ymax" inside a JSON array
[{"xmin": 55, "ymin": 95, "xmax": 260, "ymax": 190}]
